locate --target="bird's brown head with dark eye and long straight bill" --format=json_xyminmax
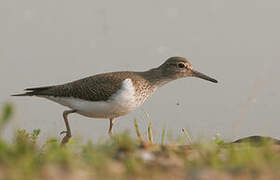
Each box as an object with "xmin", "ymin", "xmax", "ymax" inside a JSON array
[{"xmin": 159, "ymin": 57, "xmax": 218, "ymax": 83}]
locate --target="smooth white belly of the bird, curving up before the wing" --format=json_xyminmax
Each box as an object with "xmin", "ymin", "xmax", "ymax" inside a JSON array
[{"xmin": 45, "ymin": 79, "xmax": 142, "ymax": 118}]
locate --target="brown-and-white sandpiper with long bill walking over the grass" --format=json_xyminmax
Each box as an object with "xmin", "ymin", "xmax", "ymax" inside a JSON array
[{"xmin": 12, "ymin": 57, "xmax": 218, "ymax": 144}]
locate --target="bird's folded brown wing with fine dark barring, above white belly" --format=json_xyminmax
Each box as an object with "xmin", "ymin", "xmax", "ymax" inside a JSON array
[{"xmin": 17, "ymin": 72, "xmax": 131, "ymax": 101}]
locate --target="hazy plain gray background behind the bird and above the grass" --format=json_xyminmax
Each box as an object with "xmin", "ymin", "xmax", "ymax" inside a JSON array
[{"xmin": 0, "ymin": 0, "xmax": 280, "ymax": 143}]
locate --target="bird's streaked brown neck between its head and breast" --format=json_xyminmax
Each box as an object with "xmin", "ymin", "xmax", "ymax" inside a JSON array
[{"xmin": 141, "ymin": 68, "xmax": 174, "ymax": 88}]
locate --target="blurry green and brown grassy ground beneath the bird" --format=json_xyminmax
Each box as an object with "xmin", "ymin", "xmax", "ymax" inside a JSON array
[{"xmin": 0, "ymin": 104, "xmax": 280, "ymax": 179}]
